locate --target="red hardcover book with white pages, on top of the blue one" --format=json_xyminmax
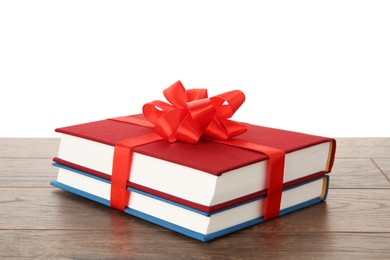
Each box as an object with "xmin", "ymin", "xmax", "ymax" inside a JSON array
[{"xmin": 54, "ymin": 80, "xmax": 336, "ymax": 212}]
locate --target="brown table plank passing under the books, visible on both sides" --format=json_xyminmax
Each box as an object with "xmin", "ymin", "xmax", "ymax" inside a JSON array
[{"xmin": 0, "ymin": 187, "xmax": 390, "ymax": 234}]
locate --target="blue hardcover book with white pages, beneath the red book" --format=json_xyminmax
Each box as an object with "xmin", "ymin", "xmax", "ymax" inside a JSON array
[{"xmin": 51, "ymin": 163, "xmax": 329, "ymax": 241}]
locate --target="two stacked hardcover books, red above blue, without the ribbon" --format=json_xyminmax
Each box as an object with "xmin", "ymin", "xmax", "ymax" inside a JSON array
[{"xmin": 51, "ymin": 116, "xmax": 336, "ymax": 241}]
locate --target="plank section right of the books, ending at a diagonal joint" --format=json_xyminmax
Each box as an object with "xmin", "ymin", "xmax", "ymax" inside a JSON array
[{"xmin": 329, "ymin": 158, "xmax": 390, "ymax": 189}]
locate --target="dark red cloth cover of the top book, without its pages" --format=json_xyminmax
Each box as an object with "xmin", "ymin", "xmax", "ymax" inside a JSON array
[{"xmin": 54, "ymin": 115, "xmax": 336, "ymax": 212}]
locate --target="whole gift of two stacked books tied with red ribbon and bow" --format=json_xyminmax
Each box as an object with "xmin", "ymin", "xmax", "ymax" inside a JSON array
[{"xmin": 52, "ymin": 82, "xmax": 336, "ymax": 241}]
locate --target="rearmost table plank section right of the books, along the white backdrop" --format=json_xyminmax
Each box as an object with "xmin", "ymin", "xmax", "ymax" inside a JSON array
[{"xmin": 336, "ymin": 138, "xmax": 390, "ymax": 158}]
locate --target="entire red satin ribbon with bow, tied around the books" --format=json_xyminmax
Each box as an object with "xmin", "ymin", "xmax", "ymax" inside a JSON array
[{"xmin": 110, "ymin": 81, "xmax": 285, "ymax": 220}]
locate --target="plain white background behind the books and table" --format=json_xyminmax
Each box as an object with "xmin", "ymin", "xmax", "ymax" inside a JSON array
[{"xmin": 0, "ymin": 0, "xmax": 390, "ymax": 137}]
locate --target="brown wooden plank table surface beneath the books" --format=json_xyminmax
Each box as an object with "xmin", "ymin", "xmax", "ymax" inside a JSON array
[{"xmin": 0, "ymin": 138, "xmax": 390, "ymax": 259}]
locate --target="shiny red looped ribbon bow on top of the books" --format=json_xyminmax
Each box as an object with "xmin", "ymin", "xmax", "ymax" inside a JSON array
[{"xmin": 143, "ymin": 81, "xmax": 247, "ymax": 144}]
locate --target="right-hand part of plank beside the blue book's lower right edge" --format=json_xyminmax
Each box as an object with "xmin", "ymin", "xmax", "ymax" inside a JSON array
[{"xmin": 272, "ymin": 189, "xmax": 390, "ymax": 232}]
